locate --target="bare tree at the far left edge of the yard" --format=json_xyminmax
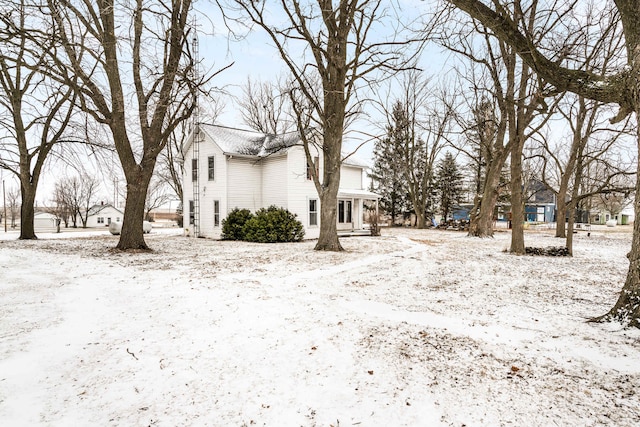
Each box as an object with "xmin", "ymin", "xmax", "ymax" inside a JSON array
[{"xmin": 0, "ymin": 0, "xmax": 76, "ymax": 239}]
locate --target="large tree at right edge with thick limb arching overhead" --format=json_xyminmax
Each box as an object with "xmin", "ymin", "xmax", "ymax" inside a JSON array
[{"xmin": 448, "ymin": 0, "xmax": 640, "ymax": 327}]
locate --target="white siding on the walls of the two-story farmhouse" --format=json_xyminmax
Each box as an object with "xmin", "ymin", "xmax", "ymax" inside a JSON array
[{"xmin": 183, "ymin": 127, "xmax": 364, "ymax": 239}]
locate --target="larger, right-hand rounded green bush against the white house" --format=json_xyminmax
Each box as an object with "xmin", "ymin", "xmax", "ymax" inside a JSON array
[{"xmin": 243, "ymin": 206, "xmax": 304, "ymax": 243}]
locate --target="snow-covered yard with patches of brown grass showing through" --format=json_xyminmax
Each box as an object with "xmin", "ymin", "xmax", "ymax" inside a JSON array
[{"xmin": 0, "ymin": 229, "xmax": 640, "ymax": 427}]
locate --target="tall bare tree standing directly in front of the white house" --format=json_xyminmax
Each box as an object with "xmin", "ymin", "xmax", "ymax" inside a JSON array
[{"xmin": 233, "ymin": 0, "xmax": 422, "ymax": 251}]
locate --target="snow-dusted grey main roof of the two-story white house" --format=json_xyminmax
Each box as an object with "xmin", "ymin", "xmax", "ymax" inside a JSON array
[{"xmin": 199, "ymin": 124, "xmax": 300, "ymax": 157}]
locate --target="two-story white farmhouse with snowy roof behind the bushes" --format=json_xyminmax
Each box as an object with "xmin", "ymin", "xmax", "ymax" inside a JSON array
[{"xmin": 183, "ymin": 124, "xmax": 379, "ymax": 239}]
